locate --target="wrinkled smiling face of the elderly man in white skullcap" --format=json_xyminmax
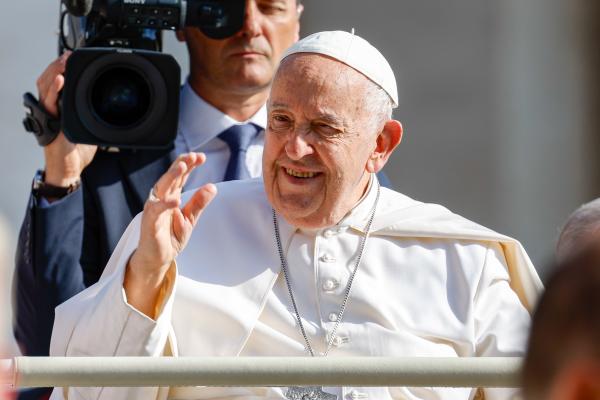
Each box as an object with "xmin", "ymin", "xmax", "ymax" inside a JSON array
[{"xmin": 263, "ymin": 53, "xmax": 378, "ymax": 228}]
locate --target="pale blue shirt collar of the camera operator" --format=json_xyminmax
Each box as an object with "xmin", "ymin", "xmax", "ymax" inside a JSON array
[{"xmin": 179, "ymin": 81, "xmax": 267, "ymax": 151}]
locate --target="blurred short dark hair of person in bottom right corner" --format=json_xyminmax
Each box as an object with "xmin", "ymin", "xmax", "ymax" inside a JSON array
[{"xmin": 522, "ymin": 242, "xmax": 600, "ymax": 399}]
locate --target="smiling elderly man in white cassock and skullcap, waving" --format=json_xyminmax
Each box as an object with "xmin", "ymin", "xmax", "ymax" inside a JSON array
[{"xmin": 51, "ymin": 32, "xmax": 541, "ymax": 400}]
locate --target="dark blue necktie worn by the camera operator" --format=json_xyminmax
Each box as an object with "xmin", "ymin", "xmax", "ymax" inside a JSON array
[{"xmin": 219, "ymin": 124, "xmax": 260, "ymax": 181}]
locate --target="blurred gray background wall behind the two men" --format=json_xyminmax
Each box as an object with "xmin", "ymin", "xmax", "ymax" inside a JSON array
[{"xmin": 0, "ymin": 0, "xmax": 600, "ymax": 354}]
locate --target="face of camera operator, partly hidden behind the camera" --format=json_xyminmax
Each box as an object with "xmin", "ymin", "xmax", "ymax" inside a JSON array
[{"xmin": 178, "ymin": 0, "xmax": 301, "ymax": 91}]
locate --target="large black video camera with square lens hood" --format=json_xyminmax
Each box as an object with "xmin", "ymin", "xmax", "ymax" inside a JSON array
[{"xmin": 59, "ymin": 0, "xmax": 245, "ymax": 148}]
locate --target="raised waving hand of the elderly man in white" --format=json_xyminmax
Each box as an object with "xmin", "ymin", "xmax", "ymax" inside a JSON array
[{"xmin": 123, "ymin": 153, "xmax": 217, "ymax": 317}]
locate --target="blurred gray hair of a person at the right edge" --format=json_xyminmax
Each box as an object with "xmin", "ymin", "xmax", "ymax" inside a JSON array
[{"xmin": 556, "ymin": 198, "xmax": 600, "ymax": 260}]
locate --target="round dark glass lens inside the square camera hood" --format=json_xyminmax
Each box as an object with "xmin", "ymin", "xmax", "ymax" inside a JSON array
[{"xmin": 90, "ymin": 67, "xmax": 152, "ymax": 128}]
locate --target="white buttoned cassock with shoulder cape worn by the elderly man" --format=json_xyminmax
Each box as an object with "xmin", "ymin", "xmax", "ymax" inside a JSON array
[{"xmin": 51, "ymin": 179, "xmax": 542, "ymax": 400}]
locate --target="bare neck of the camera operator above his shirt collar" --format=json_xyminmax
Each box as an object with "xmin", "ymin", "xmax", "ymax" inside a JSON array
[{"xmin": 189, "ymin": 74, "xmax": 269, "ymax": 122}]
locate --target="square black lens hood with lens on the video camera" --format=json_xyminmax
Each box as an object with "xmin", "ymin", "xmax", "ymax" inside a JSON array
[{"xmin": 62, "ymin": 47, "xmax": 180, "ymax": 148}]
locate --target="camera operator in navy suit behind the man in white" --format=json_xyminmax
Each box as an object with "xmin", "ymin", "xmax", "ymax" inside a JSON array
[{"xmin": 14, "ymin": 0, "xmax": 303, "ymax": 356}]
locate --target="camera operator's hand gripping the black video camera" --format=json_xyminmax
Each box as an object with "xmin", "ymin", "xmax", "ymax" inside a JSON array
[{"xmin": 36, "ymin": 52, "xmax": 97, "ymax": 187}]
